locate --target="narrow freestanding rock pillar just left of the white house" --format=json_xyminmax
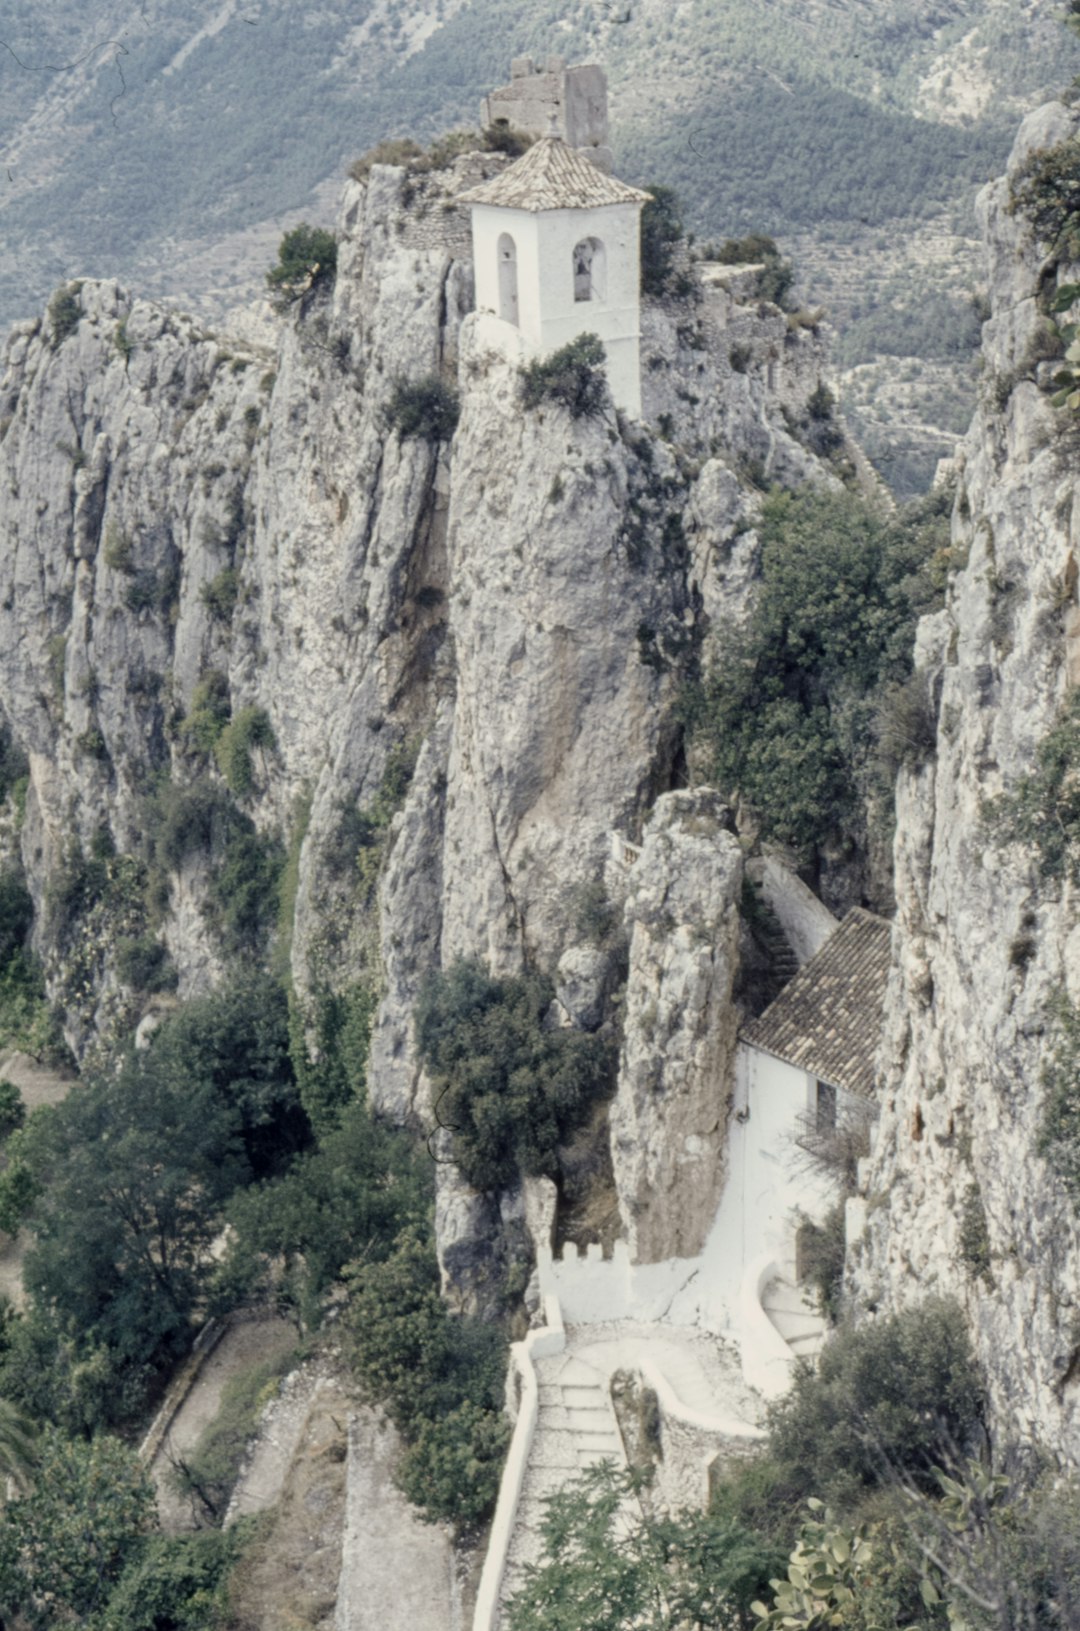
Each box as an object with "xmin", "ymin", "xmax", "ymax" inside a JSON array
[{"xmin": 610, "ymin": 791, "xmax": 742, "ymax": 1262}]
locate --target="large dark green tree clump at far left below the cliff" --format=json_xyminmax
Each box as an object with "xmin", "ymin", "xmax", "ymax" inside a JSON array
[{"xmin": 3, "ymin": 977, "xmax": 308, "ymax": 1425}]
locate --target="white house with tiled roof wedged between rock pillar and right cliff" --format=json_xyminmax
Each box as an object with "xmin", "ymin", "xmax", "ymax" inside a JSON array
[{"xmin": 706, "ymin": 907, "xmax": 891, "ymax": 1293}]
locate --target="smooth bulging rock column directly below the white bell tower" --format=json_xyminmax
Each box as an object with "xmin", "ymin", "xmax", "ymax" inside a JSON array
[{"xmin": 444, "ymin": 322, "xmax": 688, "ymax": 969}]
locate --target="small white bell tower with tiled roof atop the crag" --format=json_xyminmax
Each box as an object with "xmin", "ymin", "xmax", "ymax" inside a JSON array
[{"xmin": 460, "ymin": 135, "xmax": 649, "ymax": 418}]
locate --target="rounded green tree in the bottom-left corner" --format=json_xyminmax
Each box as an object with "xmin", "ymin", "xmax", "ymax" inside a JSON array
[{"xmin": 0, "ymin": 1429, "xmax": 157, "ymax": 1628}]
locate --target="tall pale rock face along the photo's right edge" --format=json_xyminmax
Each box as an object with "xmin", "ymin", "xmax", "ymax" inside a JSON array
[{"xmin": 852, "ymin": 106, "xmax": 1080, "ymax": 1460}]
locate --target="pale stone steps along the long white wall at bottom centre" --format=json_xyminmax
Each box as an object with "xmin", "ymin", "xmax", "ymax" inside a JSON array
[{"xmin": 499, "ymin": 1354, "xmax": 626, "ymax": 1605}]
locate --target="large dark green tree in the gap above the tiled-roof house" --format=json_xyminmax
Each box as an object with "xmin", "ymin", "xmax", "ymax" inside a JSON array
[{"xmin": 695, "ymin": 489, "xmax": 948, "ymax": 860}]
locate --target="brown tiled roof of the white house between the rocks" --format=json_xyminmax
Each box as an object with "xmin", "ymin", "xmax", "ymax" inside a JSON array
[{"xmin": 741, "ymin": 907, "xmax": 891, "ymax": 1098}]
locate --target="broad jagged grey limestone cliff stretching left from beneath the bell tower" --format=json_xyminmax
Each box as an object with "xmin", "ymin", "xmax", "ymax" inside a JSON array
[{"xmin": 0, "ymin": 140, "xmax": 827, "ymax": 1280}]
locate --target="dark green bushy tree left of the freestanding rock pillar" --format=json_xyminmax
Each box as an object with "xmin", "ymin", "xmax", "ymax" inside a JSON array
[{"xmin": 416, "ymin": 961, "xmax": 613, "ymax": 1189}]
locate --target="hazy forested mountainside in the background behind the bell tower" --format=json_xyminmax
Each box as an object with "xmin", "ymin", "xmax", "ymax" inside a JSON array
[{"xmin": 0, "ymin": 0, "xmax": 1069, "ymax": 351}]
